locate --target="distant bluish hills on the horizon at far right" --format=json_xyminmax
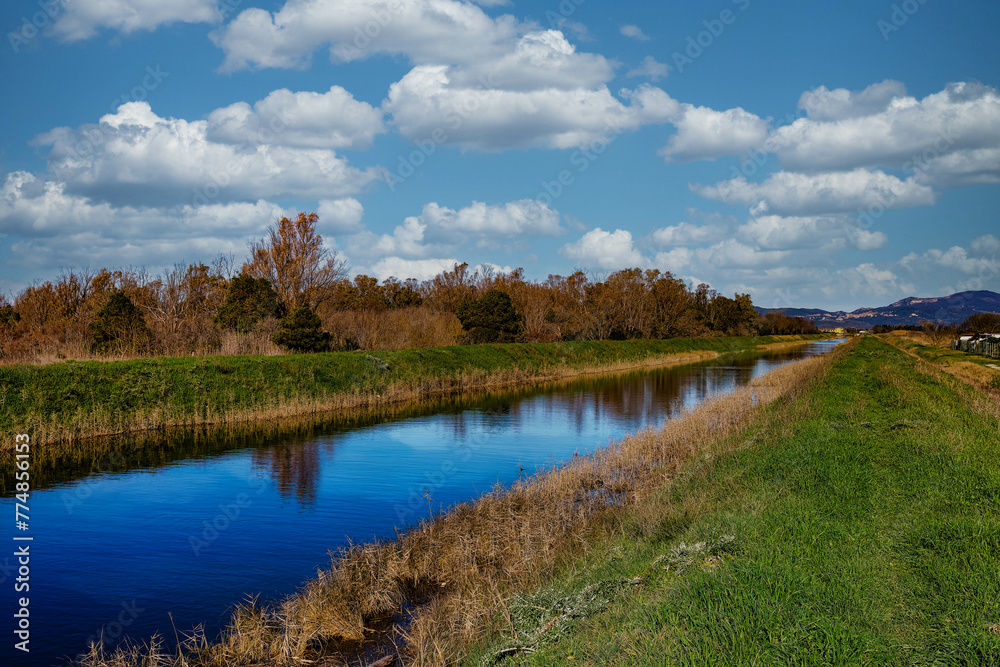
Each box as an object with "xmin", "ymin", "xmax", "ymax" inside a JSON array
[{"xmin": 757, "ymin": 290, "xmax": 1000, "ymax": 329}]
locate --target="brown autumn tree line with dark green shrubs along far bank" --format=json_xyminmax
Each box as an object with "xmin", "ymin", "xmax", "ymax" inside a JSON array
[{"xmin": 0, "ymin": 213, "xmax": 816, "ymax": 363}]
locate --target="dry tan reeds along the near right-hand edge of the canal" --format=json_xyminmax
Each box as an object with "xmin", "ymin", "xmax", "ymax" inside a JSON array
[{"xmin": 85, "ymin": 344, "xmax": 840, "ymax": 667}]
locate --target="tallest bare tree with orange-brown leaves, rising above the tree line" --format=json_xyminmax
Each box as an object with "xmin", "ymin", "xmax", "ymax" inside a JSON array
[{"xmin": 243, "ymin": 213, "xmax": 347, "ymax": 311}]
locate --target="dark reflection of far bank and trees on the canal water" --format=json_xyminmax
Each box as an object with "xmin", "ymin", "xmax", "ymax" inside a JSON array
[{"xmin": 9, "ymin": 342, "xmax": 834, "ymax": 496}]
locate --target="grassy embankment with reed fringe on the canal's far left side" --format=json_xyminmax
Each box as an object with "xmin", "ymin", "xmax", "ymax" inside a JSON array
[{"xmin": 0, "ymin": 336, "xmax": 818, "ymax": 448}]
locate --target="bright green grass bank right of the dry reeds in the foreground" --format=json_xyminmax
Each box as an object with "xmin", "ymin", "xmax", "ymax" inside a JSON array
[{"xmin": 469, "ymin": 337, "xmax": 1000, "ymax": 667}]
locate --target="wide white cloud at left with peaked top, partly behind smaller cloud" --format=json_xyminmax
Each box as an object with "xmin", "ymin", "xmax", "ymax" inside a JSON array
[{"xmin": 36, "ymin": 102, "xmax": 381, "ymax": 205}]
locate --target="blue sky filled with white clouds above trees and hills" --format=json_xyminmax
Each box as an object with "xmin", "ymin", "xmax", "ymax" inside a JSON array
[{"xmin": 0, "ymin": 0, "xmax": 1000, "ymax": 309}]
